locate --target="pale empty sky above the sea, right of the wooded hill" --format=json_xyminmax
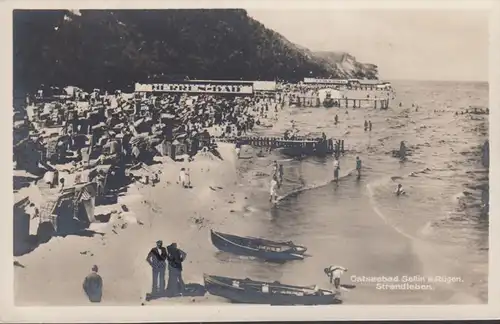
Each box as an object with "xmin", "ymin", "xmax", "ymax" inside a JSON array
[{"xmin": 247, "ymin": 9, "xmax": 489, "ymax": 81}]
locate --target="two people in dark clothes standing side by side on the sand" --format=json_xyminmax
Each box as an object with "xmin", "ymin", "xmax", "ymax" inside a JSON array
[{"xmin": 146, "ymin": 241, "xmax": 186, "ymax": 297}]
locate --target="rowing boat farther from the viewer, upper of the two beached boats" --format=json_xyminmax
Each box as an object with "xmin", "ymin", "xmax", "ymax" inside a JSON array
[{"xmin": 211, "ymin": 231, "xmax": 306, "ymax": 261}]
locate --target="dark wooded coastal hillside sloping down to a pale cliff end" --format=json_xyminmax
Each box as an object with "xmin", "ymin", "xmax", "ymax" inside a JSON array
[{"xmin": 13, "ymin": 9, "xmax": 377, "ymax": 93}]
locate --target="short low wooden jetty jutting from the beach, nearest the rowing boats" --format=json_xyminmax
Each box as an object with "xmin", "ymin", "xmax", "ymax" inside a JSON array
[{"xmin": 216, "ymin": 137, "xmax": 345, "ymax": 156}]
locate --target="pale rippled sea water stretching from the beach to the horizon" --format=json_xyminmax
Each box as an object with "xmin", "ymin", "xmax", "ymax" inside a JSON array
[{"xmin": 224, "ymin": 82, "xmax": 488, "ymax": 304}]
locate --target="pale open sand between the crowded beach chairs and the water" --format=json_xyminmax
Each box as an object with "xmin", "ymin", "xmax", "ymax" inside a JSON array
[{"xmin": 15, "ymin": 143, "xmax": 252, "ymax": 305}]
